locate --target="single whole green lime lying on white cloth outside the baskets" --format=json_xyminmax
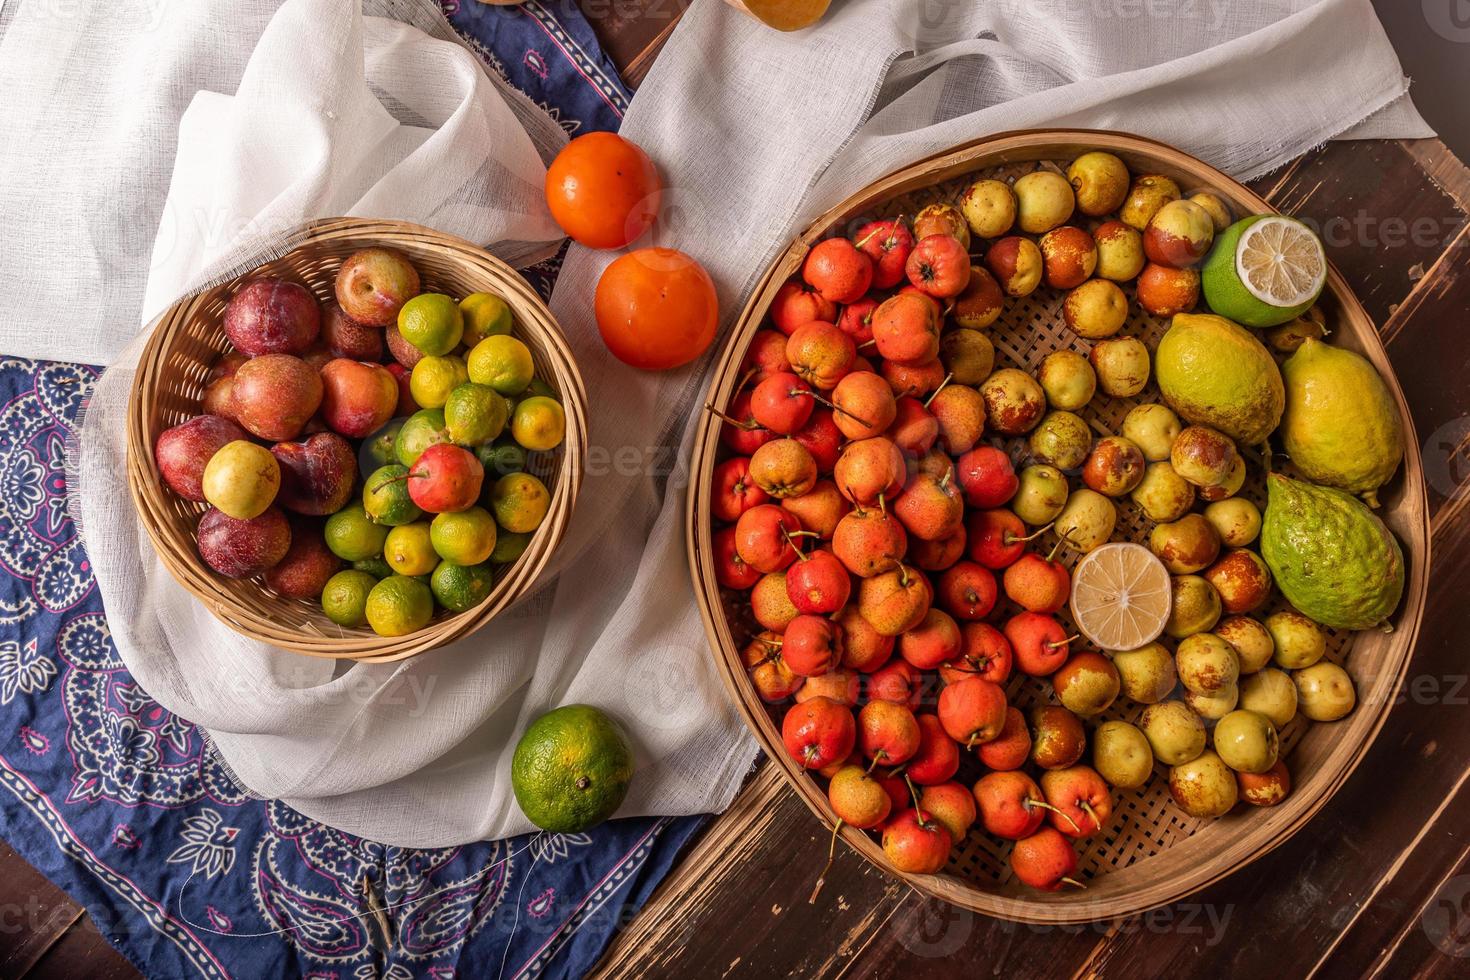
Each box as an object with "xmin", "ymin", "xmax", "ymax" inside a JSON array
[{"xmin": 510, "ymin": 704, "xmax": 634, "ymax": 833}]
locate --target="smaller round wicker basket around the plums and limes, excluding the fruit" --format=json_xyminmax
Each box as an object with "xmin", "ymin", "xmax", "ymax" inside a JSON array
[{"xmin": 128, "ymin": 217, "xmax": 587, "ymax": 663}]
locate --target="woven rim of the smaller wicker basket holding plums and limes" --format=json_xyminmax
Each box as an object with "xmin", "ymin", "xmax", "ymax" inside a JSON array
[{"xmin": 126, "ymin": 217, "xmax": 588, "ymax": 663}]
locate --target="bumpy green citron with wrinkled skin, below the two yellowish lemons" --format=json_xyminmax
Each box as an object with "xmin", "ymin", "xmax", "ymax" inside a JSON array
[{"xmin": 1261, "ymin": 473, "xmax": 1404, "ymax": 629}]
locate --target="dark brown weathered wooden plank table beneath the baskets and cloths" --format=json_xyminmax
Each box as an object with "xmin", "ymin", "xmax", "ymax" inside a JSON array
[{"xmin": 11, "ymin": 7, "xmax": 1470, "ymax": 980}]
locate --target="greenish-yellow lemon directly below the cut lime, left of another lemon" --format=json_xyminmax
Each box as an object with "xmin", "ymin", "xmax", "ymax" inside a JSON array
[{"xmin": 1154, "ymin": 313, "xmax": 1286, "ymax": 445}]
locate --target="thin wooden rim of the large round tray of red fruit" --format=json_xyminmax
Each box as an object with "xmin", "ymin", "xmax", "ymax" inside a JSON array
[{"xmin": 685, "ymin": 128, "xmax": 1430, "ymax": 926}]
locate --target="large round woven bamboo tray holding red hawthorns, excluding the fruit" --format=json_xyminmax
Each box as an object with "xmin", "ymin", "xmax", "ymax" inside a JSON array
[{"xmin": 686, "ymin": 131, "xmax": 1429, "ymax": 924}]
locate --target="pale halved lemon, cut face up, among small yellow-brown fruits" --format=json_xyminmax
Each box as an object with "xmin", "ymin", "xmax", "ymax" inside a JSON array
[{"xmin": 1072, "ymin": 541, "xmax": 1173, "ymax": 649}]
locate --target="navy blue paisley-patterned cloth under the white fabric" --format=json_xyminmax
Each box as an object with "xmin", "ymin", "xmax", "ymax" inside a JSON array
[{"xmin": 0, "ymin": 7, "xmax": 704, "ymax": 980}]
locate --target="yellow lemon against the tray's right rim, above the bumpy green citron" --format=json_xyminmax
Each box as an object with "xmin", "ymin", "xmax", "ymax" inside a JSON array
[{"xmin": 1280, "ymin": 338, "xmax": 1404, "ymax": 507}]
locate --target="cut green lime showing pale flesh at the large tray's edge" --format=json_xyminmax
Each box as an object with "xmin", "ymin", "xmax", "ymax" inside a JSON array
[{"xmin": 1201, "ymin": 215, "xmax": 1327, "ymax": 326}]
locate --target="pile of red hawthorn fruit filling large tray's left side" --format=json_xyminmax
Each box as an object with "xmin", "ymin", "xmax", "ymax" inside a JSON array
[{"xmin": 713, "ymin": 196, "xmax": 1111, "ymax": 890}]
